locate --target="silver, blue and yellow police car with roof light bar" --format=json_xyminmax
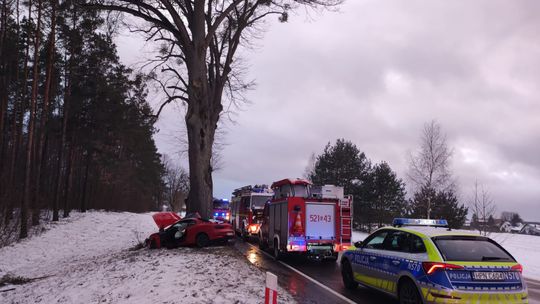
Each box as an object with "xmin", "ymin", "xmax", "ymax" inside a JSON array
[{"xmin": 340, "ymin": 218, "xmax": 528, "ymax": 304}]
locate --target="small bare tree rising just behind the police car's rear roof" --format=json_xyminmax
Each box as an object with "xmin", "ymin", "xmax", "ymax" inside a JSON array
[{"xmin": 469, "ymin": 181, "xmax": 497, "ymax": 235}]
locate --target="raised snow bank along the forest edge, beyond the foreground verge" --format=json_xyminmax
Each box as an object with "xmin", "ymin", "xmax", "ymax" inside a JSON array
[{"xmin": 0, "ymin": 212, "xmax": 151, "ymax": 276}]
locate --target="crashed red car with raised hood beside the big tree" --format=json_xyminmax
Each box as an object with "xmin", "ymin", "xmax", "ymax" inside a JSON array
[{"xmin": 146, "ymin": 212, "xmax": 234, "ymax": 248}]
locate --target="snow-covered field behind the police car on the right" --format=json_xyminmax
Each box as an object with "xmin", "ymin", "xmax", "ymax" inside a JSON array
[{"xmin": 353, "ymin": 231, "xmax": 540, "ymax": 280}]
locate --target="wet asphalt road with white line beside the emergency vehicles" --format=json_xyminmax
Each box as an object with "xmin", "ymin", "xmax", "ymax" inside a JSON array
[{"xmin": 234, "ymin": 239, "xmax": 540, "ymax": 304}]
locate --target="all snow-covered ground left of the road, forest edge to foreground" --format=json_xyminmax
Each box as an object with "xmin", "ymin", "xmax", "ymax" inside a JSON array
[{"xmin": 0, "ymin": 212, "xmax": 294, "ymax": 303}]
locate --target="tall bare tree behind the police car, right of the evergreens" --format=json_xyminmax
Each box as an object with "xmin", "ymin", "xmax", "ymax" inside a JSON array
[{"xmin": 407, "ymin": 120, "xmax": 454, "ymax": 218}]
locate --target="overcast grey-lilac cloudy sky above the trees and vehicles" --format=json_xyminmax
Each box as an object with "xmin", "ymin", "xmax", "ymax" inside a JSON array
[{"xmin": 118, "ymin": 0, "xmax": 540, "ymax": 220}]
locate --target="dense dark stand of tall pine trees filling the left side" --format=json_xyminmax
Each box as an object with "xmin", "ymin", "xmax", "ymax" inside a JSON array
[{"xmin": 0, "ymin": 0, "xmax": 167, "ymax": 243}]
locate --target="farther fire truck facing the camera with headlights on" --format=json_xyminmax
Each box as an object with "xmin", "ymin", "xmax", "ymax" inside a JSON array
[{"xmin": 230, "ymin": 185, "xmax": 273, "ymax": 239}]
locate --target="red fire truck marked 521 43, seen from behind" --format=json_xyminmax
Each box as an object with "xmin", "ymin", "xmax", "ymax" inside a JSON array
[{"xmin": 259, "ymin": 179, "xmax": 353, "ymax": 260}]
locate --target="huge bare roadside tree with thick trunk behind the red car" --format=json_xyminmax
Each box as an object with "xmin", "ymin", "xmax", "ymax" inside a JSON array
[{"xmin": 89, "ymin": 0, "xmax": 343, "ymax": 217}]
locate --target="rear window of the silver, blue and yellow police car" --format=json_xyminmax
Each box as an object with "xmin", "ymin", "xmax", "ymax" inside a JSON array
[{"xmin": 432, "ymin": 236, "xmax": 515, "ymax": 262}]
